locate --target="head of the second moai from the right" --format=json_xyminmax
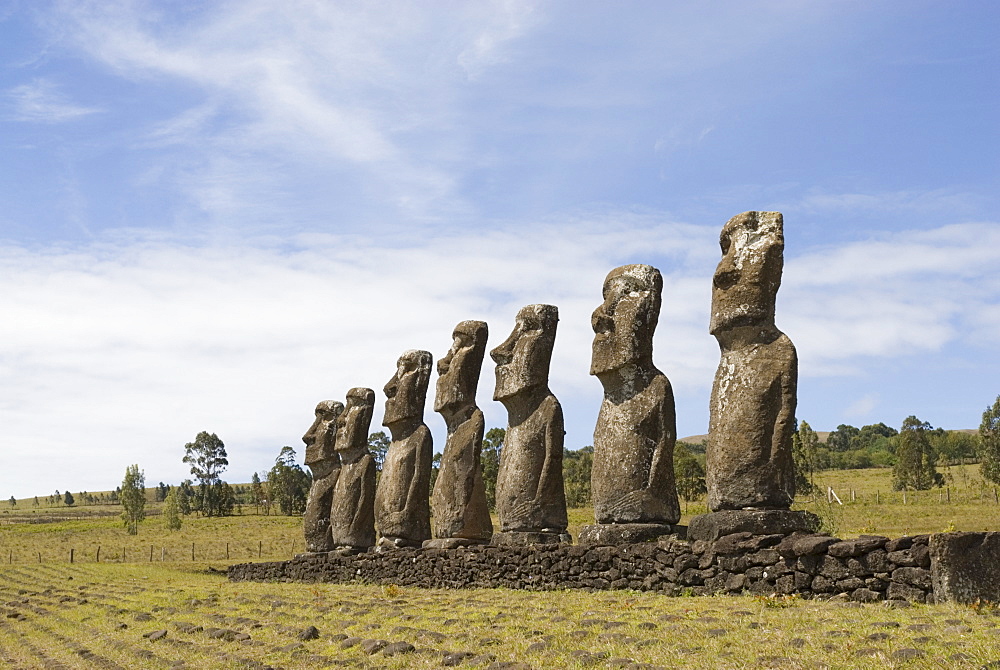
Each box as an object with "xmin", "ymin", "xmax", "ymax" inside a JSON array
[{"xmin": 590, "ymin": 265, "xmax": 663, "ymax": 375}]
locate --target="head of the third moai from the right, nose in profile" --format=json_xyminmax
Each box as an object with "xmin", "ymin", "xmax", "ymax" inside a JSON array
[{"xmin": 490, "ymin": 305, "xmax": 559, "ymax": 400}]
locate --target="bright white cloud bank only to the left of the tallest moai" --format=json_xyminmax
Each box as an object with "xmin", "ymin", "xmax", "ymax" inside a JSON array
[{"xmin": 0, "ymin": 221, "xmax": 714, "ymax": 495}]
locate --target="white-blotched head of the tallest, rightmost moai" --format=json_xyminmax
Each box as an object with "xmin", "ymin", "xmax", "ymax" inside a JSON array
[{"xmin": 709, "ymin": 212, "xmax": 785, "ymax": 335}]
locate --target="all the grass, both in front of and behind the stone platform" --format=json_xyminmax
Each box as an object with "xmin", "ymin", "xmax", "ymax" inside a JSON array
[{"xmin": 0, "ymin": 466, "xmax": 1000, "ymax": 669}]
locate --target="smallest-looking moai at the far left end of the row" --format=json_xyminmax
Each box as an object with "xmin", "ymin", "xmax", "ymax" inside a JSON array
[{"xmin": 302, "ymin": 400, "xmax": 344, "ymax": 551}]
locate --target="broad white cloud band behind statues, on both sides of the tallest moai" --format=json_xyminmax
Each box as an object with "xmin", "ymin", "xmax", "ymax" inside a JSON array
[{"xmin": 0, "ymin": 215, "xmax": 1000, "ymax": 495}]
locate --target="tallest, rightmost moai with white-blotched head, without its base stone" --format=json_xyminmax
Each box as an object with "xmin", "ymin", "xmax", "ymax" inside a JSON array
[{"xmin": 706, "ymin": 212, "xmax": 798, "ymax": 511}]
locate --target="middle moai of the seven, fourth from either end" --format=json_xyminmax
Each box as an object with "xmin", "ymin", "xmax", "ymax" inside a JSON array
[{"xmin": 424, "ymin": 321, "xmax": 493, "ymax": 548}]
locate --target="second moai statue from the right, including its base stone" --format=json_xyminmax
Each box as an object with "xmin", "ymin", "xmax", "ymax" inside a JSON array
[{"xmin": 580, "ymin": 265, "xmax": 681, "ymax": 544}]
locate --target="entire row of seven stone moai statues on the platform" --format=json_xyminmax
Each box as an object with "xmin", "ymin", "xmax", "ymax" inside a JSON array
[{"xmin": 303, "ymin": 212, "xmax": 809, "ymax": 553}]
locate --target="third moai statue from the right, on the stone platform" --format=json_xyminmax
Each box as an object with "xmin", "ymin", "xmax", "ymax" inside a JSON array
[{"xmin": 490, "ymin": 305, "xmax": 571, "ymax": 544}]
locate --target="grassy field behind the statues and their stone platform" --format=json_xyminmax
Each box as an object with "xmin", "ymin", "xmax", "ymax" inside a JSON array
[{"xmin": 0, "ymin": 465, "xmax": 1000, "ymax": 566}]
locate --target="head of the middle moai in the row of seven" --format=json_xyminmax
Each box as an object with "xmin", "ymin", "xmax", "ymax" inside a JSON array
[{"xmin": 434, "ymin": 321, "xmax": 489, "ymax": 412}]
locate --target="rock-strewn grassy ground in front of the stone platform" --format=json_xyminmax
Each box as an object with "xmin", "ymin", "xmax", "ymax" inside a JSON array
[{"xmin": 0, "ymin": 564, "xmax": 1000, "ymax": 670}]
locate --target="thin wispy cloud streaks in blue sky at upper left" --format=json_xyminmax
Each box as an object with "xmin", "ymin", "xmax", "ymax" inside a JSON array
[{"xmin": 43, "ymin": 0, "xmax": 548, "ymax": 226}]
